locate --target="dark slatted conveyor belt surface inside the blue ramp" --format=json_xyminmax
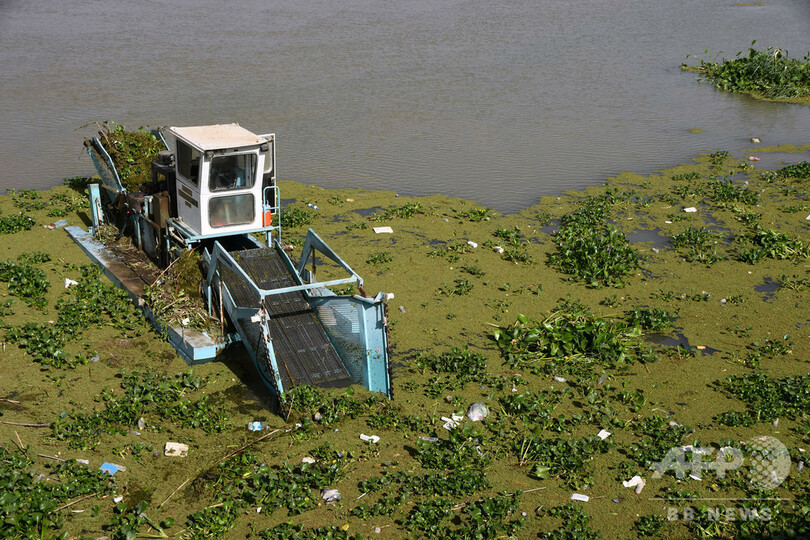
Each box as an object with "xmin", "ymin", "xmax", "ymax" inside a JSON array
[{"xmin": 222, "ymin": 248, "xmax": 354, "ymax": 389}]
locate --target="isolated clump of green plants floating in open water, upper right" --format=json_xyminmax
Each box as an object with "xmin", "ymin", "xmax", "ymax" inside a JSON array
[{"xmin": 681, "ymin": 41, "xmax": 810, "ymax": 99}]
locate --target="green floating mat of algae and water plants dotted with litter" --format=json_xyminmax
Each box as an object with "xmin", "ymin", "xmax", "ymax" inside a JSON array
[{"xmin": 0, "ymin": 146, "xmax": 810, "ymax": 538}]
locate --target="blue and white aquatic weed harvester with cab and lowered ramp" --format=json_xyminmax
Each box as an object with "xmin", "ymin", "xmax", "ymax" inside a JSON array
[{"xmin": 71, "ymin": 124, "xmax": 391, "ymax": 397}]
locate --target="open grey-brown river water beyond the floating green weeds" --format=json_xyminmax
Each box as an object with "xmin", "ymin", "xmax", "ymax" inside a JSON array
[{"xmin": 0, "ymin": 0, "xmax": 810, "ymax": 211}]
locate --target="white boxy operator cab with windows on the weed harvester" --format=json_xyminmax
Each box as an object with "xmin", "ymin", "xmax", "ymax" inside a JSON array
[{"xmin": 164, "ymin": 124, "xmax": 278, "ymax": 237}]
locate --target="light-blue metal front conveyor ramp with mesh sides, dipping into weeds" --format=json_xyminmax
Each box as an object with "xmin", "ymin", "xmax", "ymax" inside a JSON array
[{"xmin": 204, "ymin": 230, "xmax": 391, "ymax": 397}]
